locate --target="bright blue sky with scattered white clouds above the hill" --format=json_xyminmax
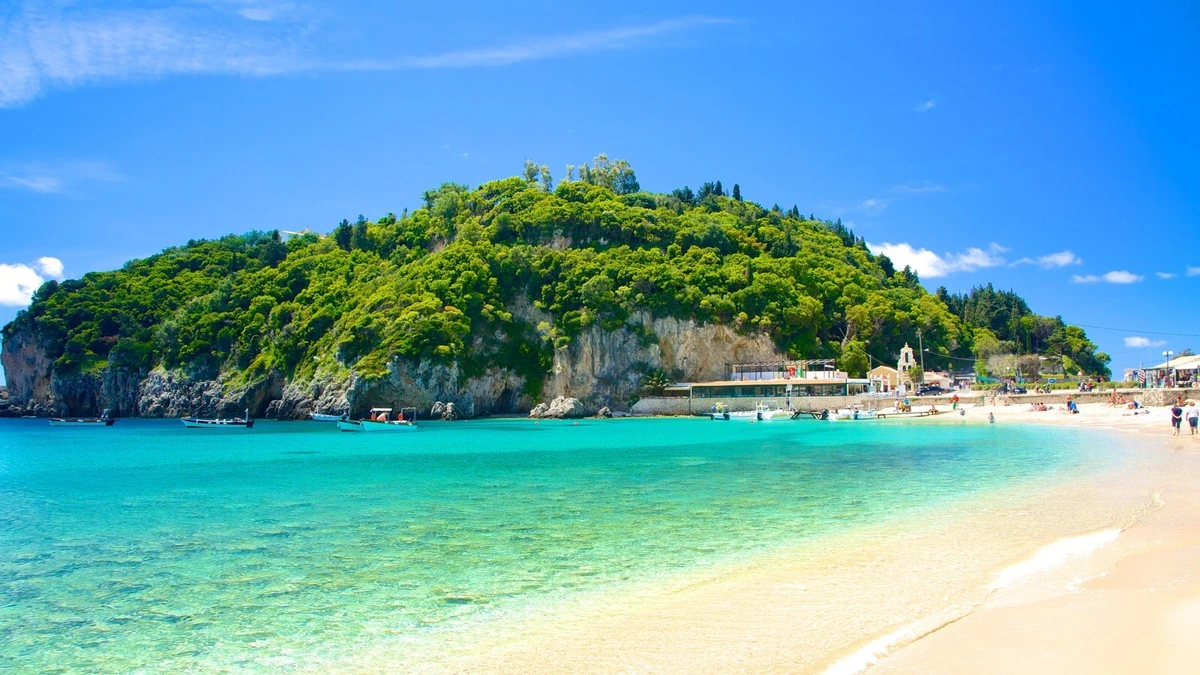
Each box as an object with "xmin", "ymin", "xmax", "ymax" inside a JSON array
[{"xmin": 0, "ymin": 0, "xmax": 1200, "ymax": 375}]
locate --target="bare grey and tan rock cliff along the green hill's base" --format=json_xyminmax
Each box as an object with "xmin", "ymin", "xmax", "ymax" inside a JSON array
[{"xmin": 0, "ymin": 313, "xmax": 784, "ymax": 419}]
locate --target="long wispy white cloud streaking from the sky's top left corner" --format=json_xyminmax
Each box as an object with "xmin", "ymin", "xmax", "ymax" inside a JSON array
[{"xmin": 0, "ymin": 0, "xmax": 736, "ymax": 108}]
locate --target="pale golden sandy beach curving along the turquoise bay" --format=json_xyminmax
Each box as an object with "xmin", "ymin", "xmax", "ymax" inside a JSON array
[{"xmin": 346, "ymin": 396, "xmax": 1200, "ymax": 674}]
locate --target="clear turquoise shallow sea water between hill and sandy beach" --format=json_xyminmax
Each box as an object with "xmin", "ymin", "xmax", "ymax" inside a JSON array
[{"xmin": 0, "ymin": 419, "xmax": 1104, "ymax": 673}]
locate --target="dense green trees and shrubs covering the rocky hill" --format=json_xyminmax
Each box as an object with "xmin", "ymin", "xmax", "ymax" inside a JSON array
[{"xmin": 5, "ymin": 156, "xmax": 1094, "ymax": 393}]
